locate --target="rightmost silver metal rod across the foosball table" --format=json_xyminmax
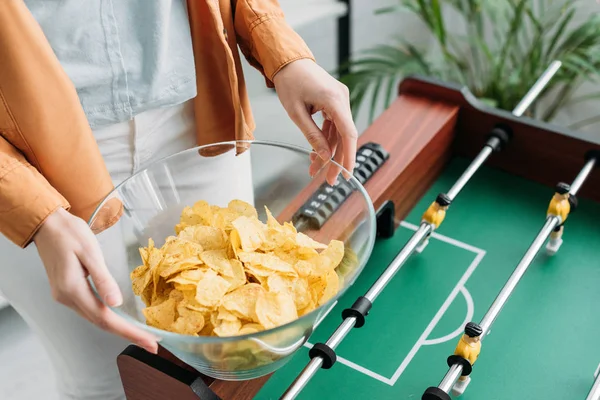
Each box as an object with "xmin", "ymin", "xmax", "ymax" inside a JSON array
[{"xmin": 438, "ymin": 158, "xmax": 600, "ymax": 393}]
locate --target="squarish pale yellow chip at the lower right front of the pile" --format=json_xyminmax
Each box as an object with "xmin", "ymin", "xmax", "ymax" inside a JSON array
[{"xmin": 256, "ymin": 292, "xmax": 298, "ymax": 329}]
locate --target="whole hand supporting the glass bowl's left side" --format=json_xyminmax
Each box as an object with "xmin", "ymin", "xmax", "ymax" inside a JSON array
[{"xmin": 33, "ymin": 208, "xmax": 158, "ymax": 354}]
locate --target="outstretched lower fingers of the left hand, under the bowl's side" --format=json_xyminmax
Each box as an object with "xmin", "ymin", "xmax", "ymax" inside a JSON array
[{"xmin": 71, "ymin": 280, "xmax": 158, "ymax": 354}]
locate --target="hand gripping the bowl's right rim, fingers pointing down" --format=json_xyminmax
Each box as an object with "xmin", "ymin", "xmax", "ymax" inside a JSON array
[{"xmin": 273, "ymin": 59, "xmax": 358, "ymax": 184}]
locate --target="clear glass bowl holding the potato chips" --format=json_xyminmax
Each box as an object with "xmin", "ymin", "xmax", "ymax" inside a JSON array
[{"xmin": 89, "ymin": 141, "xmax": 376, "ymax": 380}]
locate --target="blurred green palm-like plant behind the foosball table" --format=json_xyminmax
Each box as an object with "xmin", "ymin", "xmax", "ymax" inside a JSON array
[{"xmin": 341, "ymin": 0, "xmax": 600, "ymax": 127}]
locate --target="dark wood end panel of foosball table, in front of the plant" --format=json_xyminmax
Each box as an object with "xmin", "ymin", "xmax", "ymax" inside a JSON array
[{"xmin": 399, "ymin": 77, "xmax": 600, "ymax": 201}]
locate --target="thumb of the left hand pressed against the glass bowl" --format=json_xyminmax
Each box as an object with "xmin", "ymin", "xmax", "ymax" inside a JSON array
[{"xmin": 76, "ymin": 237, "xmax": 123, "ymax": 307}]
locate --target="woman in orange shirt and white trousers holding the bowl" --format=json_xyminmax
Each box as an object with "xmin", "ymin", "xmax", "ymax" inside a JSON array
[{"xmin": 0, "ymin": 0, "xmax": 357, "ymax": 400}]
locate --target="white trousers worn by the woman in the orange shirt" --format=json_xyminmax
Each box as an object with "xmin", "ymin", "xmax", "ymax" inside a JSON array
[{"xmin": 0, "ymin": 102, "xmax": 253, "ymax": 400}]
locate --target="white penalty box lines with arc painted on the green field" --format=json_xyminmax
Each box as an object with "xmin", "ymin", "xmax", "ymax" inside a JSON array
[{"xmin": 304, "ymin": 221, "xmax": 486, "ymax": 386}]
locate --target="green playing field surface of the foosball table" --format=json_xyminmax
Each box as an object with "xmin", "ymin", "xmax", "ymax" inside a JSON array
[{"xmin": 255, "ymin": 159, "xmax": 600, "ymax": 400}]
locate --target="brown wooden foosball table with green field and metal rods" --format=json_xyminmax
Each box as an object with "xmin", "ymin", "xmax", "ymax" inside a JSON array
[{"xmin": 118, "ymin": 65, "xmax": 600, "ymax": 400}]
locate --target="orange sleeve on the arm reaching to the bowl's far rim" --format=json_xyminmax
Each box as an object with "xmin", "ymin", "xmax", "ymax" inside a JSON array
[{"xmin": 233, "ymin": 0, "xmax": 314, "ymax": 87}]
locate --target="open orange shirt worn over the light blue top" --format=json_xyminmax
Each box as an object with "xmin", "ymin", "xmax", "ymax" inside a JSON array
[{"xmin": 0, "ymin": 0, "xmax": 313, "ymax": 247}]
